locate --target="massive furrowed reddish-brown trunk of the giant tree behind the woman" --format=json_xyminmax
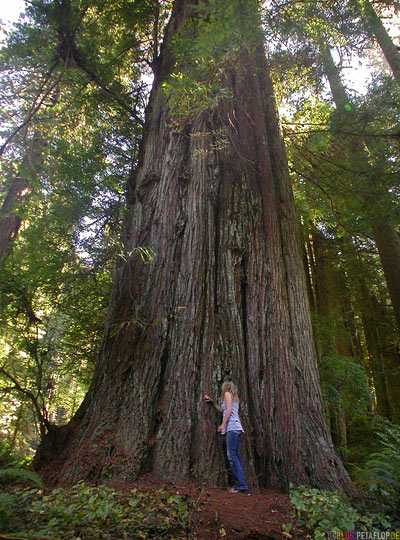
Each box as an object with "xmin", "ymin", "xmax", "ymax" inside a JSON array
[{"xmin": 35, "ymin": 0, "xmax": 349, "ymax": 489}]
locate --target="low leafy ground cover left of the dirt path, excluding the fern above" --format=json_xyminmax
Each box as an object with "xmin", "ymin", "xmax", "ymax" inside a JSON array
[{"xmin": 2, "ymin": 482, "xmax": 191, "ymax": 540}]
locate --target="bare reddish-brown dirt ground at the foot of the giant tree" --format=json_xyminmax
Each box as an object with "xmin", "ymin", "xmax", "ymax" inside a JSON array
[{"xmin": 113, "ymin": 477, "xmax": 311, "ymax": 540}]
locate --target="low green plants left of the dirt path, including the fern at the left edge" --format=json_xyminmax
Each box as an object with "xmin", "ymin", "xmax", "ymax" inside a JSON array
[{"xmin": 0, "ymin": 443, "xmax": 193, "ymax": 540}]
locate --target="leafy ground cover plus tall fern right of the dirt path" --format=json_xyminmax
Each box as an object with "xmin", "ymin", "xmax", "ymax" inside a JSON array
[{"xmin": 283, "ymin": 419, "xmax": 400, "ymax": 540}]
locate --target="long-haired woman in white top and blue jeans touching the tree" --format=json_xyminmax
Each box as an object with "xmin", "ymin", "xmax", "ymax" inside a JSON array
[{"xmin": 204, "ymin": 381, "xmax": 247, "ymax": 493}]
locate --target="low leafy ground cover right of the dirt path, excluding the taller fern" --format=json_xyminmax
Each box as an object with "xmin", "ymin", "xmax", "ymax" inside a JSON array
[{"xmin": 290, "ymin": 486, "xmax": 391, "ymax": 540}]
